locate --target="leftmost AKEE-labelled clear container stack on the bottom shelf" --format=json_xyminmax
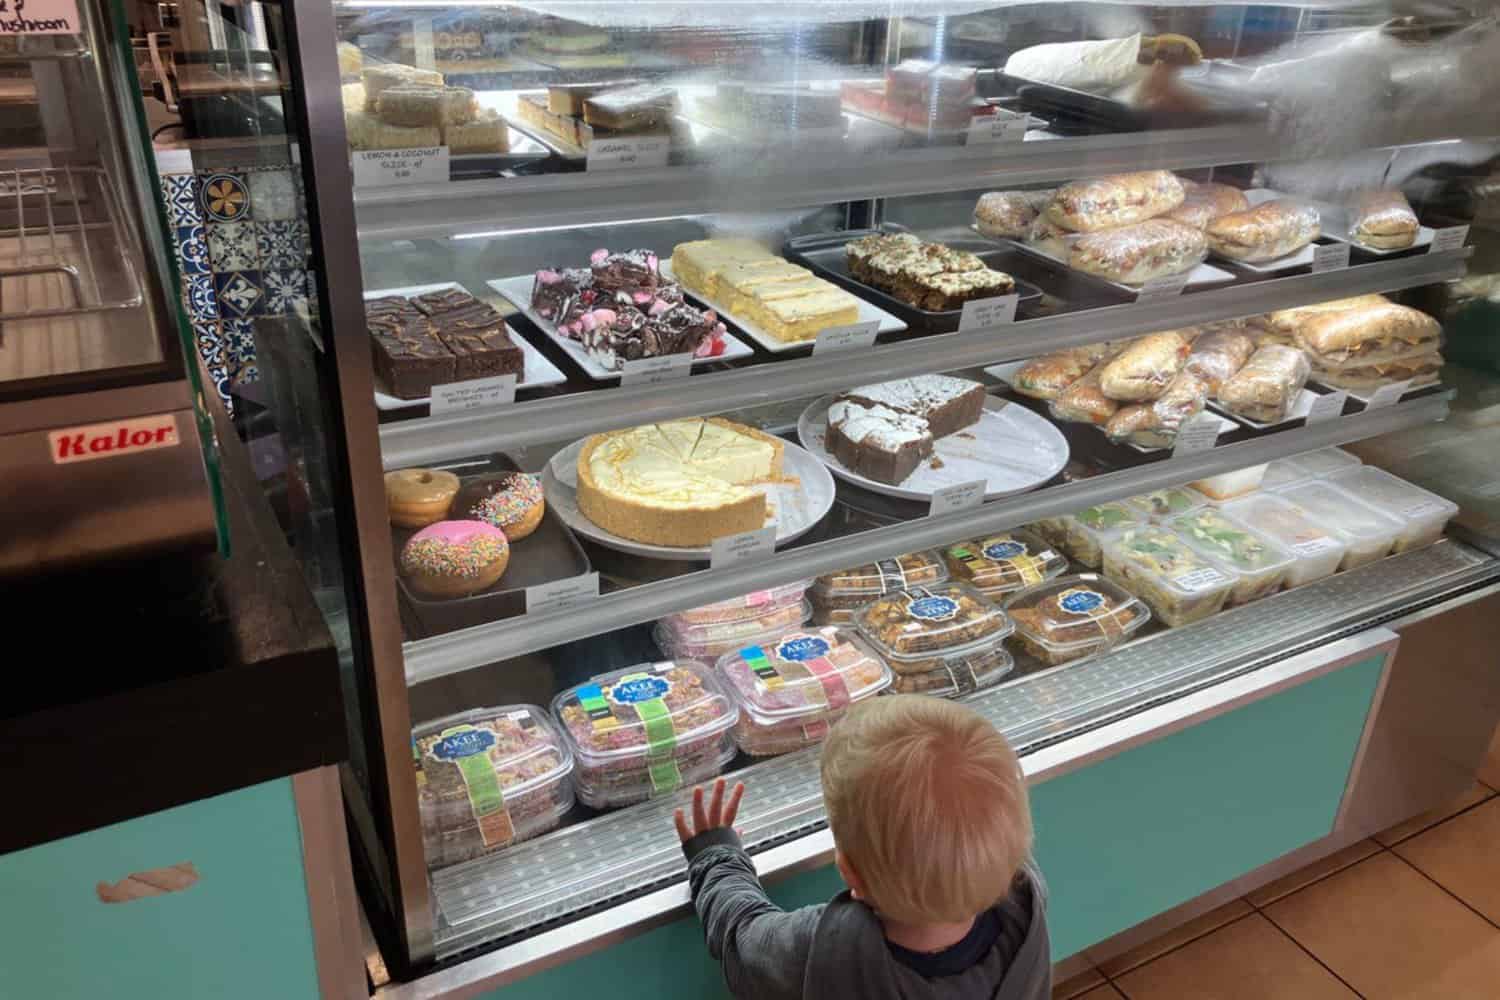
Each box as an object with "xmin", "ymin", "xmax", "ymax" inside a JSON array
[{"xmin": 411, "ymin": 705, "xmax": 573, "ymax": 868}]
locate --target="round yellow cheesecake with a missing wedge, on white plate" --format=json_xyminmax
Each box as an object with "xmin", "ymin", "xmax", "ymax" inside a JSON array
[{"xmin": 578, "ymin": 417, "xmax": 783, "ymax": 547}]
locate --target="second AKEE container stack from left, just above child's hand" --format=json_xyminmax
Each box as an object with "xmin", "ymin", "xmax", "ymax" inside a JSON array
[{"xmin": 552, "ymin": 660, "xmax": 740, "ymax": 810}]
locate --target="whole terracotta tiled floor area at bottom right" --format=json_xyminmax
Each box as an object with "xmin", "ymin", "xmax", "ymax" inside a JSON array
[{"xmin": 1053, "ymin": 733, "xmax": 1500, "ymax": 1000}]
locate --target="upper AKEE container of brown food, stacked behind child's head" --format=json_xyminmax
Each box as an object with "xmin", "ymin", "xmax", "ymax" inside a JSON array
[{"xmin": 855, "ymin": 582, "xmax": 1013, "ymax": 661}]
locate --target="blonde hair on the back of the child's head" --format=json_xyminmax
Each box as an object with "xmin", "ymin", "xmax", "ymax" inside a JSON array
[{"xmin": 822, "ymin": 694, "xmax": 1032, "ymax": 924}]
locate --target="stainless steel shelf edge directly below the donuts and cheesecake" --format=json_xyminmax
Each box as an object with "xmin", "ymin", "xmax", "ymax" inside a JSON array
[{"xmin": 404, "ymin": 393, "xmax": 1448, "ymax": 684}]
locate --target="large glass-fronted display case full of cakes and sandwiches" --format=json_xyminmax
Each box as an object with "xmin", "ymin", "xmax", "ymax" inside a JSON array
[{"xmin": 149, "ymin": 0, "xmax": 1500, "ymax": 996}]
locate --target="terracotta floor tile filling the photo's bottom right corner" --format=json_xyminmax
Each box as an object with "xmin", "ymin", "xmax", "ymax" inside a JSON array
[{"xmin": 1265, "ymin": 852, "xmax": 1500, "ymax": 1000}]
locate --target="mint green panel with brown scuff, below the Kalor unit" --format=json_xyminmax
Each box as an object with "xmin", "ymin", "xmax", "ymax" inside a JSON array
[{"xmin": 0, "ymin": 779, "xmax": 318, "ymax": 1000}]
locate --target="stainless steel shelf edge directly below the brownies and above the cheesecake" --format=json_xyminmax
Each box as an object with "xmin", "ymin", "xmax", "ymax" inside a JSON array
[{"xmin": 380, "ymin": 247, "xmax": 1470, "ymax": 469}]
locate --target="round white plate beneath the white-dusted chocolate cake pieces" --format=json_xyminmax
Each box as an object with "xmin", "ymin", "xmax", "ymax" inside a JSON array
[{"xmin": 797, "ymin": 394, "xmax": 1068, "ymax": 501}]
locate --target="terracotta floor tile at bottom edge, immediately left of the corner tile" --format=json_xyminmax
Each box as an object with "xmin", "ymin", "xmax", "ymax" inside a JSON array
[{"xmin": 1118, "ymin": 913, "xmax": 1358, "ymax": 1000}]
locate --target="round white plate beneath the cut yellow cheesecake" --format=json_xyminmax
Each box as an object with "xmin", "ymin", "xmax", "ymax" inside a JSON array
[{"xmin": 542, "ymin": 438, "xmax": 834, "ymax": 561}]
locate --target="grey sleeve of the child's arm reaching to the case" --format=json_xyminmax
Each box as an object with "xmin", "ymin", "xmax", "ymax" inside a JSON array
[{"xmin": 683, "ymin": 831, "xmax": 824, "ymax": 1000}]
